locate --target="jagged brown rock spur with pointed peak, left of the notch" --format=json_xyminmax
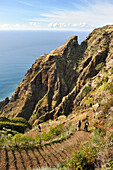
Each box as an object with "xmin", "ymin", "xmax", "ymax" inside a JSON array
[{"xmin": 1, "ymin": 36, "xmax": 84, "ymax": 121}]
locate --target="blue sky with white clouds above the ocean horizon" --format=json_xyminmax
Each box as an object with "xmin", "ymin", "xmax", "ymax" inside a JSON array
[{"xmin": 0, "ymin": 0, "xmax": 113, "ymax": 31}]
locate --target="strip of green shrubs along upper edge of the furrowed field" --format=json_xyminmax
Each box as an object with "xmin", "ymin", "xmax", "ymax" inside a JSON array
[{"xmin": 0, "ymin": 120, "xmax": 75, "ymax": 147}]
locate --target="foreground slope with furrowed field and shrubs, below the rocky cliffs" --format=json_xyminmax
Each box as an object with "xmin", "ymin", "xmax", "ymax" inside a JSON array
[{"xmin": 0, "ymin": 105, "xmax": 113, "ymax": 170}]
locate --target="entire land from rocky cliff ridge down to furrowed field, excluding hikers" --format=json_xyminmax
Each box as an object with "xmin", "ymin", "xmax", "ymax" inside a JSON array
[{"xmin": 0, "ymin": 25, "xmax": 113, "ymax": 170}]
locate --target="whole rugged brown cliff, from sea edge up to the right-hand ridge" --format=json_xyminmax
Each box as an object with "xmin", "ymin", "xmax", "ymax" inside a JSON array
[{"xmin": 0, "ymin": 26, "xmax": 113, "ymax": 125}]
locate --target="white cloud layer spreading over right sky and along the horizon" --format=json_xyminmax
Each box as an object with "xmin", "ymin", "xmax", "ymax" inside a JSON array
[{"xmin": 0, "ymin": 0, "xmax": 113, "ymax": 30}]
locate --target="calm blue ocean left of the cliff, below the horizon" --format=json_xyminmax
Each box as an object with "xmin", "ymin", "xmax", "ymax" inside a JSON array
[{"xmin": 0, "ymin": 31, "xmax": 89, "ymax": 101}]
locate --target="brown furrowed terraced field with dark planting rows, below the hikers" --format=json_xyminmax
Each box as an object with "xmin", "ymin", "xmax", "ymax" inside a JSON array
[{"xmin": 0, "ymin": 131, "xmax": 89, "ymax": 170}]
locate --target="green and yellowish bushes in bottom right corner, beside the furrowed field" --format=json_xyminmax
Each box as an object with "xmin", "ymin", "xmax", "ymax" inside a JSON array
[{"xmin": 64, "ymin": 127, "xmax": 113, "ymax": 170}]
